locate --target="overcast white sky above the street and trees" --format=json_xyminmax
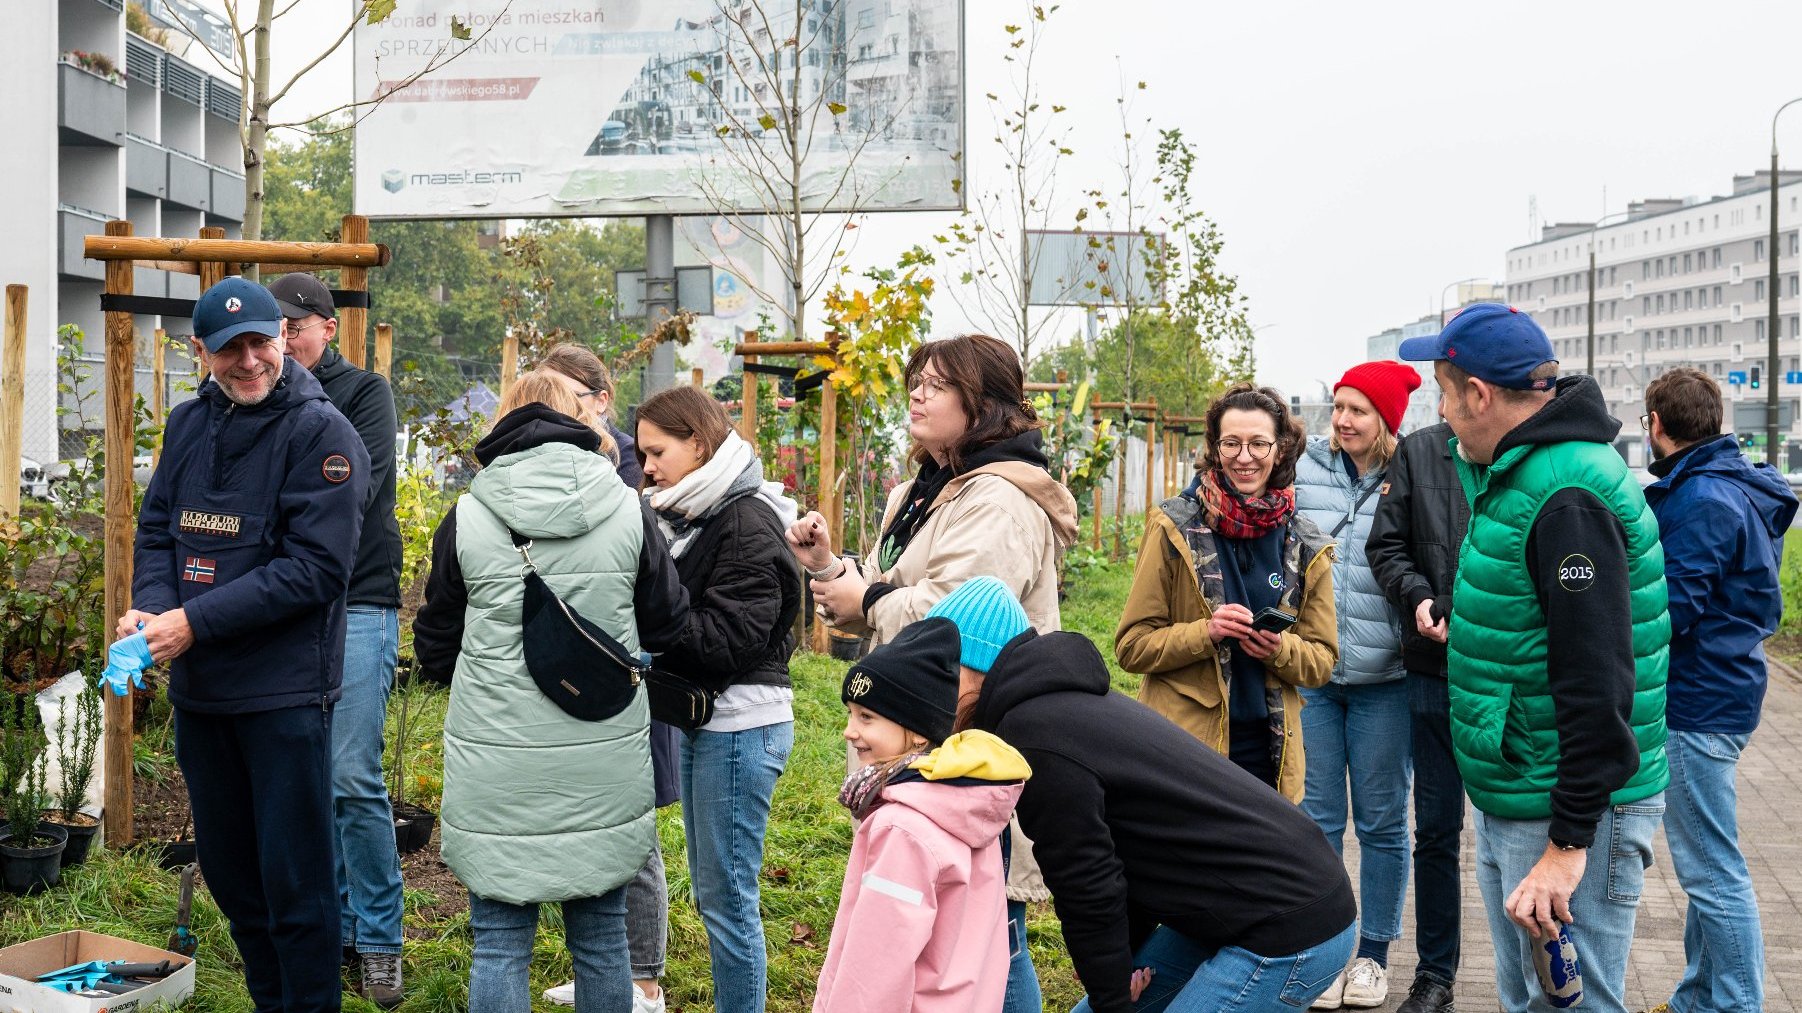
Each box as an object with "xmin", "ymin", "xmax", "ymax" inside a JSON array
[{"xmin": 272, "ymin": 0, "xmax": 1802, "ymax": 393}]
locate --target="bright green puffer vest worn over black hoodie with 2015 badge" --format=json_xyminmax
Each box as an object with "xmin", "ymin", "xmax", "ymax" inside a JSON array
[{"xmin": 1449, "ymin": 440, "xmax": 1670, "ymax": 820}]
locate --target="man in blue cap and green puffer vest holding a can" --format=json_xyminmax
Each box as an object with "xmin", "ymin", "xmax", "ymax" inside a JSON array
[{"xmin": 1400, "ymin": 303, "xmax": 1670, "ymax": 1013}]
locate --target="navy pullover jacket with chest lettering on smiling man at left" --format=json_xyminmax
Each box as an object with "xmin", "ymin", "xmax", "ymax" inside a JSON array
[{"xmin": 132, "ymin": 359, "xmax": 369, "ymax": 714}]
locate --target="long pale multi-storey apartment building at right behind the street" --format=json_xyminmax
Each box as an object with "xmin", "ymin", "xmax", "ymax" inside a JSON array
[{"xmin": 1506, "ymin": 171, "xmax": 1802, "ymax": 470}]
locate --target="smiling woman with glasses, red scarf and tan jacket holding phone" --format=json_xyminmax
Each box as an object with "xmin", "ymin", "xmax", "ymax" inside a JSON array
[{"xmin": 1114, "ymin": 384, "xmax": 1339, "ymax": 804}]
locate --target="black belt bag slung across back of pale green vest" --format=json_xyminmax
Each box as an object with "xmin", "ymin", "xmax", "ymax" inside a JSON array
[{"xmin": 506, "ymin": 528, "xmax": 651, "ymax": 721}]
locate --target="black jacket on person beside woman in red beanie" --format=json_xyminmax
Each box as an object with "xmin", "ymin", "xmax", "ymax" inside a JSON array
[{"xmin": 1364, "ymin": 422, "xmax": 1470, "ymax": 680}]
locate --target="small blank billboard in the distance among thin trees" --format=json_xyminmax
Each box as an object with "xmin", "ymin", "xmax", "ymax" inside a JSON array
[{"xmin": 1020, "ymin": 229, "xmax": 1164, "ymax": 306}]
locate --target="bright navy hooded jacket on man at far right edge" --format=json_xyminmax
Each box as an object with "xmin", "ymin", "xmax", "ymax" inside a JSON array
[{"xmin": 1645, "ymin": 428, "xmax": 1797, "ymax": 734}]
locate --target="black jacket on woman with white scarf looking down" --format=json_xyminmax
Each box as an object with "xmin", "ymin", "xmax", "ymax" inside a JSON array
[{"xmin": 658, "ymin": 494, "xmax": 800, "ymax": 690}]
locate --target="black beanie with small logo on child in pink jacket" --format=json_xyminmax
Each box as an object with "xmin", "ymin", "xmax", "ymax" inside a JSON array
[{"xmin": 840, "ymin": 618, "xmax": 962, "ymax": 743}]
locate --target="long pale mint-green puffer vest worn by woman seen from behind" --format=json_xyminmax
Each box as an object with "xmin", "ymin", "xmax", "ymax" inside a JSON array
[{"xmin": 440, "ymin": 443, "xmax": 656, "ymax": 905}]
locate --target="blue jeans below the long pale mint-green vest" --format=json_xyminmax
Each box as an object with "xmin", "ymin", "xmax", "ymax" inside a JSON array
[{"xmin": 469, "ymin": 887, "xmax": 633, "ymax": 1013}]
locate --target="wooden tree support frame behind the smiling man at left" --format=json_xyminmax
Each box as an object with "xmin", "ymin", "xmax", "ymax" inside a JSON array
[{"xmin": 81, "ymin": 214, "xmax": 389, "ymax": 847}]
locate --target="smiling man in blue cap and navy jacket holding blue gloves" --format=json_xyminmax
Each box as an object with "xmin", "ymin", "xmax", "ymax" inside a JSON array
[{"xmin": 117, "ymin": 278, "xmax": 369, "ymax": 1013}]
